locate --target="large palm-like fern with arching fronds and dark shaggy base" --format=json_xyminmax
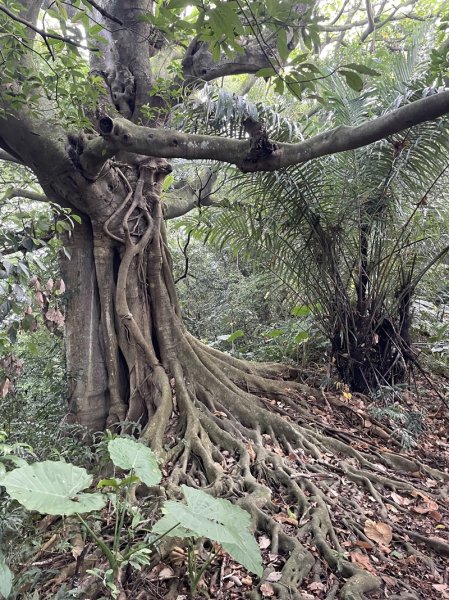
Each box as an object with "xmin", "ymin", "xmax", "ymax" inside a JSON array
[{"xmin": 174, "ymin": 45, "xmax": 449, "ymax": 391}]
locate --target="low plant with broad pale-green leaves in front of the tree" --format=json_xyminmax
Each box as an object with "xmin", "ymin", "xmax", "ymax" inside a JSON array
[{"xmin": 0, "ymin": 437, "xmax": 262, "ymax": 599}]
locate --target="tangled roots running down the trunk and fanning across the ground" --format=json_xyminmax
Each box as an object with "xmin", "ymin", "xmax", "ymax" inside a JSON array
[{"xmin": 83, "ymin": 161, "xmax": 449, "ymax": 600}]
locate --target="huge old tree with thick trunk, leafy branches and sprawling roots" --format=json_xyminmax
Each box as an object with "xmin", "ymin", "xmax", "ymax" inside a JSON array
[{"xmin": 0, "ymin": 0, "xmax": 449, "ymax": 599}]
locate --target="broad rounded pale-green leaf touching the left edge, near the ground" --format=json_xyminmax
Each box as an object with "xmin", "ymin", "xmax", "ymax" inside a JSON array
[{"xmin": 2, "ymin": 460, "xmax": 106, "ymax": 515}]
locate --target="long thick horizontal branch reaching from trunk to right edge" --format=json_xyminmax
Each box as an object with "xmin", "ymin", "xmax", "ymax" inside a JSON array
[{"xmin": 80, "ymin": 92, "xmax": 449, "ymax": 179}]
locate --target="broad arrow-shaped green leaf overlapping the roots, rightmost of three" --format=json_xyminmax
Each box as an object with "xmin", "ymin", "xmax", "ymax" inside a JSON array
[{"xmin": 153, "ymin": 485, "xmax": 263, "ymax": 577}]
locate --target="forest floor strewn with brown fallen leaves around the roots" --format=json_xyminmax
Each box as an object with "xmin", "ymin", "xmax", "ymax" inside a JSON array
[{"xmin": 21, "ymin": 366, "xmax": 449, "ymax": 600}]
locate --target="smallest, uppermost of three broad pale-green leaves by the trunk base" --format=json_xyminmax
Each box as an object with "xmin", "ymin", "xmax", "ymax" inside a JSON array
[{"xmin": 108, "ymin": 438, "xmax": 162, "ymax": 486}]
